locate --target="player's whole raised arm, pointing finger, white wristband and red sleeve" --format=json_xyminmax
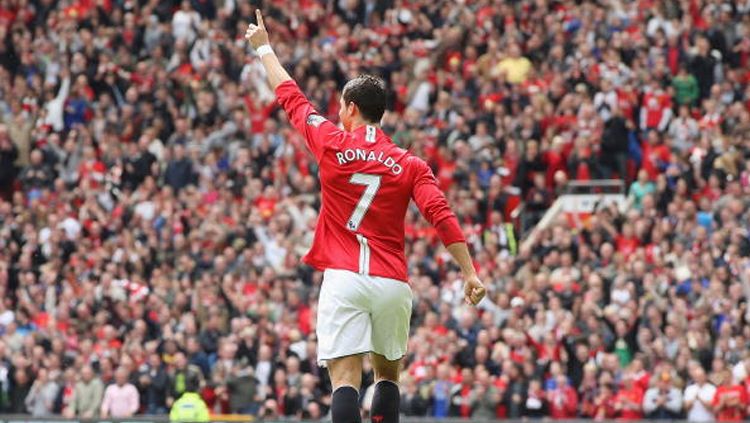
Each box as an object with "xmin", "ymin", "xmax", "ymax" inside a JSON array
[{"xmin": 245, "ymin": 9, "xmax": 345, "ymax": 162}]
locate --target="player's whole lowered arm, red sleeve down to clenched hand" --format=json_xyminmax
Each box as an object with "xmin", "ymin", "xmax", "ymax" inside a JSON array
[{"xmin": 412, "ymin": 158, "xmax": 485, "ymax": 305}]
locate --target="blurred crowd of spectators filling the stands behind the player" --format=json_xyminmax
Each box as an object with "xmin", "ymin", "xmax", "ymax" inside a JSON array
[{"xmin": 0, "ymin": 0, "xmax": 750, "ymax": 421}]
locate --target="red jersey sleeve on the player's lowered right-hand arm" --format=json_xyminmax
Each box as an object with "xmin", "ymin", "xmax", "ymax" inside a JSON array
[{"xmin": 412, "ymin": 158, "xmax": 465, "ymax": 246}]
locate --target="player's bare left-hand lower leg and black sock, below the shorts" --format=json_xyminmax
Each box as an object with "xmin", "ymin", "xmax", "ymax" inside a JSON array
[{"xmin": 327, "ymin": 354, "xmax": 363, "ymax": 423}]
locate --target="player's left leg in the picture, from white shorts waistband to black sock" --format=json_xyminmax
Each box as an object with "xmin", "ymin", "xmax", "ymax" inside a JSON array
[{"xmin": 316, "ymin": 270, "xmax": 372, "ymax": 423}]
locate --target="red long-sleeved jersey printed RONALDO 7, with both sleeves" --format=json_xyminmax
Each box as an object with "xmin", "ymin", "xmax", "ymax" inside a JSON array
[{"xmin": 276, "ymin": 81, "xmax": 464, "ymax": 281}]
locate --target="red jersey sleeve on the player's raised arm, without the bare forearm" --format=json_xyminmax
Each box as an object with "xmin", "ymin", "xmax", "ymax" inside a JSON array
[{"xmin": 276, "ymin": 80, "xmax": 345, "ymax": 162}]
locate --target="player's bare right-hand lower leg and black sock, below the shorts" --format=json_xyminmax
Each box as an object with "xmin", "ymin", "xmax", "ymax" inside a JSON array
[{"xmin": 370, "ymin": 353, "xmax": 401, "ymax": 423}]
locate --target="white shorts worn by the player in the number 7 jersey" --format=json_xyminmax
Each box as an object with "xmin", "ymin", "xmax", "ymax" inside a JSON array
[{"xmin": 316, "ymin": 269, "xmax": 412, "ymax": 365}]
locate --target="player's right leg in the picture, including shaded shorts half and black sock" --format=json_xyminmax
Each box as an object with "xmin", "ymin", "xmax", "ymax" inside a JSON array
[{"xmin": 370, "ymin": 278, "xmax": 412, "ymax": 423}]
